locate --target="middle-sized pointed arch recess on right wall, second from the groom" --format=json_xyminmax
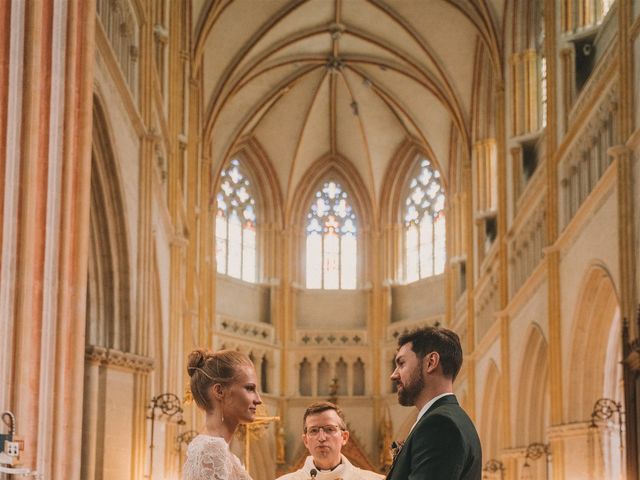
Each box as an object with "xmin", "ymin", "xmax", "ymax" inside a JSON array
[{"xmin": 515, "ymin": 323, "xmax": 549, "ymax": 446}]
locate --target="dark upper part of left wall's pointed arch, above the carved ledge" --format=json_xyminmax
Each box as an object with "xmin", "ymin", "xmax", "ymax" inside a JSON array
[{"xmin": 86, "ymin": 96, "xmax": 132, "ymax": 352}]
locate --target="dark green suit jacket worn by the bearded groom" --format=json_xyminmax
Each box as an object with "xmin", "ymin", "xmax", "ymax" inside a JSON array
[{"xmin": 387, "ymin": 395, "xmax": 482, "ymax": 480}]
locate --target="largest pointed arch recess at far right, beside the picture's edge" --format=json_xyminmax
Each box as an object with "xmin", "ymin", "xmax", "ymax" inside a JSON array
[{"xmin": 566, "ymin": 263, "xmax": 622, "ymax": 421}]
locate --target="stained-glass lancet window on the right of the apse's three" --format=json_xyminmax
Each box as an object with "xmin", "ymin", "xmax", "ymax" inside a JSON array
[{"xmin": 403, "ymin": 158, "xmax": 447, "ymax": 282}]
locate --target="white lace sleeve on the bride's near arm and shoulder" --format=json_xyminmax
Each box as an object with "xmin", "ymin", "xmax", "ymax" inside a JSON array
[{"xmin": 182, "ymin": 437, "xmax": 231, "ymax": 480}]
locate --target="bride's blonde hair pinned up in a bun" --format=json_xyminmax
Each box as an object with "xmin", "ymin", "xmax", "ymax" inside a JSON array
[{"xmin": 187, "ymin": 350, "xmax": 253, "ymax": 412}]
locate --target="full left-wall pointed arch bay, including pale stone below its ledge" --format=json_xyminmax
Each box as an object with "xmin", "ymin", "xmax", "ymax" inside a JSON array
[{"xmin": 80, "ymin": 94, "xmax": 135, "ymax": 478}]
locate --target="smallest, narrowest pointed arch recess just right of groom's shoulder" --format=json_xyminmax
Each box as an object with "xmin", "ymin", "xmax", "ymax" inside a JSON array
[{"xmin": 480, "ymin": 360, "xmax": 503, "ymax": 458}]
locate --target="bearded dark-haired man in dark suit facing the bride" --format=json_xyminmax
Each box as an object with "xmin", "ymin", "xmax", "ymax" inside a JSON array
[{"xmin": 387, "ymin": 327, "xmax": 482, "ymax": 480}]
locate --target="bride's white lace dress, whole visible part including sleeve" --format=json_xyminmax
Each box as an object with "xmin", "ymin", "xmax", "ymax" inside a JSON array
[{"xmin": 182, "ymin": 435, "xmax": 251, "ymax": 480}]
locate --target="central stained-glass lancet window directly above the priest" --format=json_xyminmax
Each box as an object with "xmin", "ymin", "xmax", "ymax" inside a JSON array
[{"xmin": 306, "ymin": 182, "xmax": 358, "ymax": 289}]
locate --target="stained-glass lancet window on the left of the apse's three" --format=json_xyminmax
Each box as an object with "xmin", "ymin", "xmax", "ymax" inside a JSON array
[{"xmin": 215, "ymin": 158, "xmax": 256, "ymax": 282}]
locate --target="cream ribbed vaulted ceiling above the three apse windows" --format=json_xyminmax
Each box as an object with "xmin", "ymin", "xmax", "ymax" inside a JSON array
[{"xmin": 192, "ymin": 0, "xmax": 504, "ymax": 208}]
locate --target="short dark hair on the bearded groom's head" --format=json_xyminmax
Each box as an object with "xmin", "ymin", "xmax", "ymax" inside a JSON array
[{"xmin": 398, "ymin": 327, "xmax": 462, "ymax": 380}]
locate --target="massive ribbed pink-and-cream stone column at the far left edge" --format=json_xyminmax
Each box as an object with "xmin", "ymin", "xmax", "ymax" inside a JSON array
[{"xmin": 0, "ymin": 0, "xmax": 95, "ymax": 480}]
